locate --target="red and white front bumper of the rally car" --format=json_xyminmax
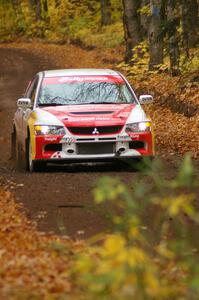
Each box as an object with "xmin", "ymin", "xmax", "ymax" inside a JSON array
[{"xmin": 32, "ymin": 132, "xmax": 154, "ymax": 163}]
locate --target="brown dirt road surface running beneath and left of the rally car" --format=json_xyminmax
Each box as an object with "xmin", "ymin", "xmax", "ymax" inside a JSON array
[{"xmin": 0, "ymin": 47, "xmax": 197, "ymax": 238}]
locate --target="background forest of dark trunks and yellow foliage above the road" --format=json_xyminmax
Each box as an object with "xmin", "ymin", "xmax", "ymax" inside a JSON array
[{"xmin": 0, "ymin": 0, "xmax": 199, "ymax": 75}]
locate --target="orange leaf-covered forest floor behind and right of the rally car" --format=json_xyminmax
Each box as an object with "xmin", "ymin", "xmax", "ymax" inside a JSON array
[{"xmin": 1, "ymin": 42, "xmax": 199, "ymax": 158}]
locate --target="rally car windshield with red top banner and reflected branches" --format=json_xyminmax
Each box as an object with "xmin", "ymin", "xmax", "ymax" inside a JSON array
[{"xmin": 38, "ymin": 75, "xmax": 136, "ymax": 106}]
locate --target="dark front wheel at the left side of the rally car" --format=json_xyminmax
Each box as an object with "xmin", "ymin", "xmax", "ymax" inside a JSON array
[{"xmin": 26, "ymin": 137, "xmax": 46, "ymax": 172}]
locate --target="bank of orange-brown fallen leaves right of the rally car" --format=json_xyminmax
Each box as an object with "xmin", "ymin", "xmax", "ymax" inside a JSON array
[{"xmin": 131, "ymin": 74, "xmax": 199, "ymax": 158}]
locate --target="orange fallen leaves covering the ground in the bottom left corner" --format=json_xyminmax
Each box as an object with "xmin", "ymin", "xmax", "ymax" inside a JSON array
[{"xmin": 0, "ymin": 190, "xmax": 84, "ymax": 300}]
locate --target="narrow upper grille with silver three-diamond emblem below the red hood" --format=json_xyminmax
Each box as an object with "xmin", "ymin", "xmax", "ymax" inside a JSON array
[{"xmin": 67, "ymin": 126, "xmax": 123, "ymax": 135}]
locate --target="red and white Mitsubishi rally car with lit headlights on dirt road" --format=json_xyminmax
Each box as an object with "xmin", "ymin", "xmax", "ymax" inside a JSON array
[{"xmin": 12, "ymin": 69, "xmax": 154, "ymax": 171}]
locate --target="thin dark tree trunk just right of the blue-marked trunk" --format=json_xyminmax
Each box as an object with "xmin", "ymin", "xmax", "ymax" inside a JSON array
[{"xmin": 167, "ymin": 0, "xmax": 180, "ymax": 76}]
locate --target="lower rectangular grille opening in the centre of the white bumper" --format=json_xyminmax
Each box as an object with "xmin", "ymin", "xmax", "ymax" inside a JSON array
[{"xmin": 77, "ymin": 143, "xmax": 115, "ymax": 155}]
